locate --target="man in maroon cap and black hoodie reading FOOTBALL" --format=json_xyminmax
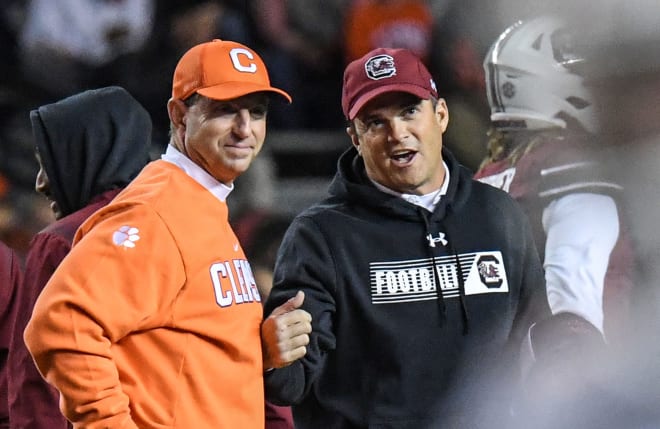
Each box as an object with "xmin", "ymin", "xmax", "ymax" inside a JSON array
[{"xmin": 263, "ymin": 49, "xmax": 550, "ymax": 429}]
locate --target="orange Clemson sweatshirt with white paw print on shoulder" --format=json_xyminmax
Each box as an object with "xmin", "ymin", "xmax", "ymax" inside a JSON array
[{"xmin": 25, "ymin": 160, "xmax": 264, "ymax": 429}]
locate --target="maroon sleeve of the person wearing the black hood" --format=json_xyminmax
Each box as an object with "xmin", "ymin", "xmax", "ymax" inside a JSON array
[{"xmin": 8, "ymin": 232, "xmax": 71, "ymax": 429}]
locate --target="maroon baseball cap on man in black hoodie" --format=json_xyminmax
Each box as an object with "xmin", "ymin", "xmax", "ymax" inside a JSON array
[{"xmin": 341, "ymin": 48, "xmax": 438, "ymax": 120}]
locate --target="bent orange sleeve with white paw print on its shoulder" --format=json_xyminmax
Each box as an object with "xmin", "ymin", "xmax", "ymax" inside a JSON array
[{"xmin": 24, "ymin": 206, "xmax": 184, "ymax": 428}]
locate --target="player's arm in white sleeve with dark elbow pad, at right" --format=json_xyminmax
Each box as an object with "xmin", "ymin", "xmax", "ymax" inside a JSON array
[{"xmin": 522, "ymin": 193, "xmax": 619, "ymax": 407}]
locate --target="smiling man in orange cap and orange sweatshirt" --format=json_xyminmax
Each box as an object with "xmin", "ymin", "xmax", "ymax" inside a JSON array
[{"xmin": 25, "ymin": 40, "xmax": 311, "ymax": 429}]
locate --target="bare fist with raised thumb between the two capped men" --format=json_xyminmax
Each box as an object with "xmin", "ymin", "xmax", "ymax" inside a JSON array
[{"xmin": 261, "ymin": 291, "xmax": 312, "ymax": 370}]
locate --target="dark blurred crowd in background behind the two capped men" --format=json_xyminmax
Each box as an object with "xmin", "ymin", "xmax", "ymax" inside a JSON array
[{"xmin": 0, "ymin": 0, "xmax": 592, "ymax": 260}]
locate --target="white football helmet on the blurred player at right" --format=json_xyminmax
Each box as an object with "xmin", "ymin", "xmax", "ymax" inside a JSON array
[{"xmin": 484, "ymin": 16, "xmax": 596, "ymax": 132}]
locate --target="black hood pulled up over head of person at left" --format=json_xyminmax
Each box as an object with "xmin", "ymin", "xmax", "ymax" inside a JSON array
[{"xmin": 30, "ymin": 86, "xmax": 151, "ymax": 216}]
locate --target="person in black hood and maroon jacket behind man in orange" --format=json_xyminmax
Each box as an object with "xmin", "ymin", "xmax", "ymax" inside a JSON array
[{"xmin": 9, "ymin": 86, "xmax": 152, "ymax": 429}]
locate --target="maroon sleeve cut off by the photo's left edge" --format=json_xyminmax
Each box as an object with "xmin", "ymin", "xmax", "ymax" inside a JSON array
[{"xmin": 0, "ymin": 243, "xmax": 21, "ymax": 429}]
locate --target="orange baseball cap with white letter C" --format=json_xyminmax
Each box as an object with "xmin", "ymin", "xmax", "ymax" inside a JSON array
[{"xmin": 172, "ymin": 39, "xmax": 291, "ymax": 103}]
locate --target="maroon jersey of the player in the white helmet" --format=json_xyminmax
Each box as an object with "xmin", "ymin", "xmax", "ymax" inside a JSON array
[{"xmin": 474, "ymin": 138, "xmax": 634, "ymax": 341}]
